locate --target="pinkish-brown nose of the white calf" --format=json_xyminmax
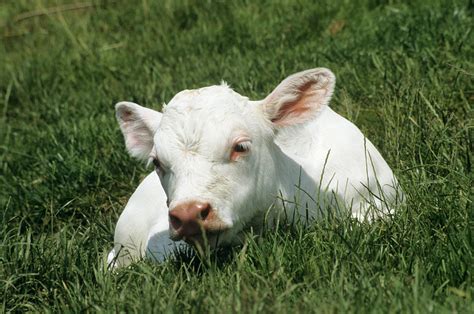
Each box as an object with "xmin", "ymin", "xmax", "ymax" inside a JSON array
[{"xmin": 169, "ymin": 202, "xmax": 211, "ymax": 237}]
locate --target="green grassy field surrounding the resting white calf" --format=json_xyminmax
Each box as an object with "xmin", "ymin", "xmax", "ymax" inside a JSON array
[{"xmin": 0, "ymin": 0, "xmax": 474, "ymax": 313}]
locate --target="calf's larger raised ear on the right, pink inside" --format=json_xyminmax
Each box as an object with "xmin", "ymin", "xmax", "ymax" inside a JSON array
[{"xmin": 263, "ymin": 68, "xmax": 336, "ymax": 126}]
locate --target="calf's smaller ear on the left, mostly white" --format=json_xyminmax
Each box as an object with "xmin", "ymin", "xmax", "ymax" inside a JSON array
[{"xmin": 115, "ymin": 101, "xmax": 161, "ymax": 160}]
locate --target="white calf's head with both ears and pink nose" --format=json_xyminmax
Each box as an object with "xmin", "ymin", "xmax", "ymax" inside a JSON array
[{"xmin": 116, "ymin": 68, "xmax": 335, "ymax": 245}]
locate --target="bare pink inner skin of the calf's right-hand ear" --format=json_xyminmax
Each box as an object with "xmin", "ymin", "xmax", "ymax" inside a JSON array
[{"xmin": 271, "ymin": 82, "xmax": 320, "ymax": 126}]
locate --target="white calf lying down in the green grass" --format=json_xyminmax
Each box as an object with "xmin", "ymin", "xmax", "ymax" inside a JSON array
[{"xmin": 109, "ymin": 68, "xmax": 401, "ymax": 265}]
